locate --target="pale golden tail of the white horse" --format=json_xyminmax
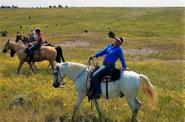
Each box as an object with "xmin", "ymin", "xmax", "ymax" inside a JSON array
[{"xmin": 140, "ymin": 74, "xmax": 158, "ymax": 109}]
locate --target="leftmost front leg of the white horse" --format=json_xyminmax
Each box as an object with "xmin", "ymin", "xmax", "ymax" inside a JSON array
[{"xmin": 72, "ymin": 92, "xmax": 85, "ymax": 120}]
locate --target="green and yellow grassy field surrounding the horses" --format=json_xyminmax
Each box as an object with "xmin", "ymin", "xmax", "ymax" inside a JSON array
[{"xmin": 0, "ymin": 8, "xmax": 185, "ymax": 122}]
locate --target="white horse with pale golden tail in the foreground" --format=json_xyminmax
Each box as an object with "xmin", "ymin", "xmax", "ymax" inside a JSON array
[{"xmin": 53, "ymin": 62, "xmax": 157, "ymax": 121}]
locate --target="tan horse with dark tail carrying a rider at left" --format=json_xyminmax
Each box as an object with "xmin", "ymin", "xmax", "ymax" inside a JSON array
[{"xmin": 3, "ymin": 40, "xmax": 65, "ymax": 73}]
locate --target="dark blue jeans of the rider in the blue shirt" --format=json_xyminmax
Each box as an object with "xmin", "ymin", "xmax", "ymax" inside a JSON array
[{"xmin": 92, "ymin": 64, "xmax": 115, "ymax": 94}]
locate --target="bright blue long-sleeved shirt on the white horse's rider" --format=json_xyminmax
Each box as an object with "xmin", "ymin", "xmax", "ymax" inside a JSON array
[{"xmin": 95, "ymin": 44, "xmax": 127, "ymax": 69}]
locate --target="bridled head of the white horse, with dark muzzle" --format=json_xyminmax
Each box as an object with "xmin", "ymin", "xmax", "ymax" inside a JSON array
[{"xmin": 53, "ymin": 65, "xmax": 64, "ymax": 88}]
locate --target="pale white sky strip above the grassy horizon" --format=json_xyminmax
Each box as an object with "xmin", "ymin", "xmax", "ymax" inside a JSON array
[{"xmin": 0, "ymin": 0, "xmax": 185, "ymax": 7}]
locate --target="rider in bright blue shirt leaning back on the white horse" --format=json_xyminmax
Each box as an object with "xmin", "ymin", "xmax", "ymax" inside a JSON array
[{"xmin": 90, "ymin": 37, "xmax": 127, "ymax": 99}]
